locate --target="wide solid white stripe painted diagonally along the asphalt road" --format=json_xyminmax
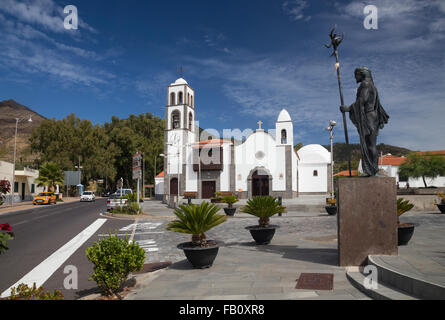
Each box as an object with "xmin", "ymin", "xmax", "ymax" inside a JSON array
[{"xmin": 1, "ymin": 219, "xmax": 107, "ymax": 298}]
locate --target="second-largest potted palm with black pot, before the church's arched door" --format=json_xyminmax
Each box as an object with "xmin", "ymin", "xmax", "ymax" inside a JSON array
[{"xmin": 241, "ymin": 196, "xmax": 286, "ymax": 244}]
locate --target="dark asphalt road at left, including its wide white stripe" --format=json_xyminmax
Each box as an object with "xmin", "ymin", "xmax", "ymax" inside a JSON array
[{"xmin": 0, "ymin": 199, "xmax": 133, "ymax": 299}]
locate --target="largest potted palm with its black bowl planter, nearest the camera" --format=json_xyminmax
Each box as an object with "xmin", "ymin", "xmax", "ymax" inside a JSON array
[{"xmin": 167, "ymin": 202, "xmax": 227, "ymax": 269}]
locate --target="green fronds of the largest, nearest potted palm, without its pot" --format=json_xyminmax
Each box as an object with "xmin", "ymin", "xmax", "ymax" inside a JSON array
[{"xmin": 167, "ymin": 201, "xmax": 227, "ymax": 247}]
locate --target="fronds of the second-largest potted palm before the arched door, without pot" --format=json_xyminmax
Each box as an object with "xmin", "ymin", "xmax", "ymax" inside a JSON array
[{"xmin": 241, "ymin": 196, "xmax": 286, "ymax": 227}]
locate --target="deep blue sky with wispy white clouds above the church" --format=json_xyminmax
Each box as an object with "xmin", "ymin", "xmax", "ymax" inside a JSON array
[{"xmin": 0, "ymin": 0, "xmax": 445, "ymax": 150}]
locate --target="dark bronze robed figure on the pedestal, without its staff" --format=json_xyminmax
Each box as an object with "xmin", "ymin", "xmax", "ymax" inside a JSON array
[{"xmin": 340, "ymin": 67, "xmax": 389, "ymax": 176}]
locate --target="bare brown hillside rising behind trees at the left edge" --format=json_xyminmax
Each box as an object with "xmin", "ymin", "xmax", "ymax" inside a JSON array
[{"xmin": 0, "ymin": 100, "xmax": 45, "ymax": 162}]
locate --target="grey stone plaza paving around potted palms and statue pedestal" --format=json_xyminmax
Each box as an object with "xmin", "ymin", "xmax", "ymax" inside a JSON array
[{"xmin": 119, "ymin": 198, "xmax": 445, "ymax": 300}]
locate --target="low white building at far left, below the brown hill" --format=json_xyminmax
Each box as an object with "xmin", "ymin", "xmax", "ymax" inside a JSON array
[{"xmin": 0, "ymin": 161, "xmax": 43, "ymax": 203}]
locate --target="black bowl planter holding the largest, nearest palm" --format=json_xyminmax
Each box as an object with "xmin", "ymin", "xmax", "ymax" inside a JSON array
[{"xmin": 178, "ymin": 240, "xmax": 219, "ymax": 269}]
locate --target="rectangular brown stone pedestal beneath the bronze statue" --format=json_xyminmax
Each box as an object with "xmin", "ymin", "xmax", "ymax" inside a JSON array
[{"xmin": 338, "ymin": 177, "xmax": 398, "ymax": 266}]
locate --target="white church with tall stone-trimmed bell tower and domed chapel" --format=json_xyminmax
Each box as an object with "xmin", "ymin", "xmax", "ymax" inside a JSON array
[{"xmin": 156, "ymin": 78, "xmax": 332, "ymax": 201}]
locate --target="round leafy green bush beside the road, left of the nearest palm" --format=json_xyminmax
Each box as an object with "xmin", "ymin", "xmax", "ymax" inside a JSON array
[{"xmin": 86, "ymin": 234, "xmax": 145, "ymax": 298}]
